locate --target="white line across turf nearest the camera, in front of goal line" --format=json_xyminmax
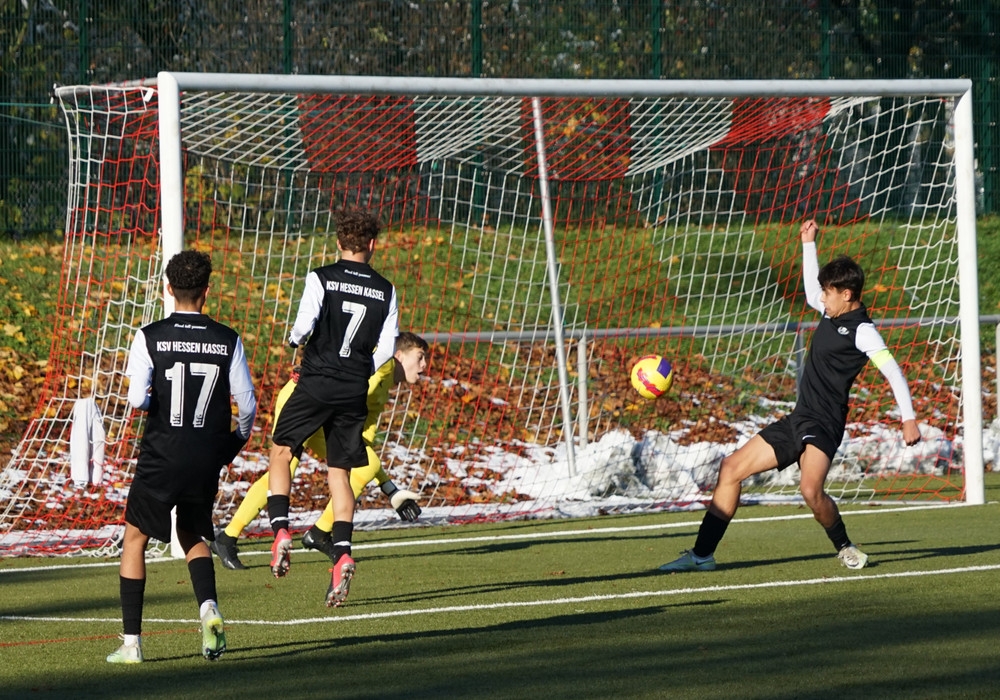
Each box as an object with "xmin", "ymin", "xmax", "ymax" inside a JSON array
[{"xmin": 7, "ymin": 564, "xmax": 1000, "ymax": 627}]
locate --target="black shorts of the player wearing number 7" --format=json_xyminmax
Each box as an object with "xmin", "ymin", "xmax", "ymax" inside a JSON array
[{"xmin": 272, "ymin": 378, "xmax": 368, "ymax": 469}]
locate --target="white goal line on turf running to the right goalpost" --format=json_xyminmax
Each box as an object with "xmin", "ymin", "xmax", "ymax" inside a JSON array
[{"xmin": 0, "ymin": 503, "xmax": 994, "ymax": 576}]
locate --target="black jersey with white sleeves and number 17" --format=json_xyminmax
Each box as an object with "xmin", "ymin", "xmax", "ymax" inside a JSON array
[{"xmin": 126, "ymin": 313, "xmax": 256, "ymax": 502}]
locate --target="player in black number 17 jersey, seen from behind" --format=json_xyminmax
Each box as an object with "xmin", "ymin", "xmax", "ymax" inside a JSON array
[{"xmin": 107, "ymin": 250, "xmax": 257, "ymax": 663}]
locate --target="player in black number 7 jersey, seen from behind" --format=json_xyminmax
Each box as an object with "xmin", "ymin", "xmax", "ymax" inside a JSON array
[{"xmin": 267, "ymin": 208, "xmax": 399, "ymax": 605}]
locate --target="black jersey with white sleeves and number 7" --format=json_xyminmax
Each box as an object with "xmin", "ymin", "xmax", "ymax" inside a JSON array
[{"xmin": 289, "ymin": 260, "xmax": 399, "ymax": 386}]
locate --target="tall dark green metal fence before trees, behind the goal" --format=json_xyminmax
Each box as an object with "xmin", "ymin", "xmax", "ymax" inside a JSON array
[{"xmin": 0, "ymin": 0, "xmax": 1000, "ymax": 236}]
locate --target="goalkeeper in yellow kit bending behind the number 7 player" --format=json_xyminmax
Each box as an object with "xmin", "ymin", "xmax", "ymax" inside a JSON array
[{"xmin": 211, "ymin": 332, "xmax": 430, "ymax": 569}]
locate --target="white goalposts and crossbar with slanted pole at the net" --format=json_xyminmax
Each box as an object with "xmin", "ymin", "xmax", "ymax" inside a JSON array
[{"xmin": 146, "ymin": 71, "xmax": 985, "ymax": 504}]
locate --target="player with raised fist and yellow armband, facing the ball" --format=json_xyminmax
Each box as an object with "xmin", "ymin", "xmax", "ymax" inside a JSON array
[{"xmin": 660, "ymin": 220, "xmax": 920, "ymax": 571}]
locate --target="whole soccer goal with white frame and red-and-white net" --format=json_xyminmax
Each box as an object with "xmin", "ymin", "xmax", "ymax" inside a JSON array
[{"xmin": 0, "ymin": 73, "xmax": 983, "ymax": 554}]
